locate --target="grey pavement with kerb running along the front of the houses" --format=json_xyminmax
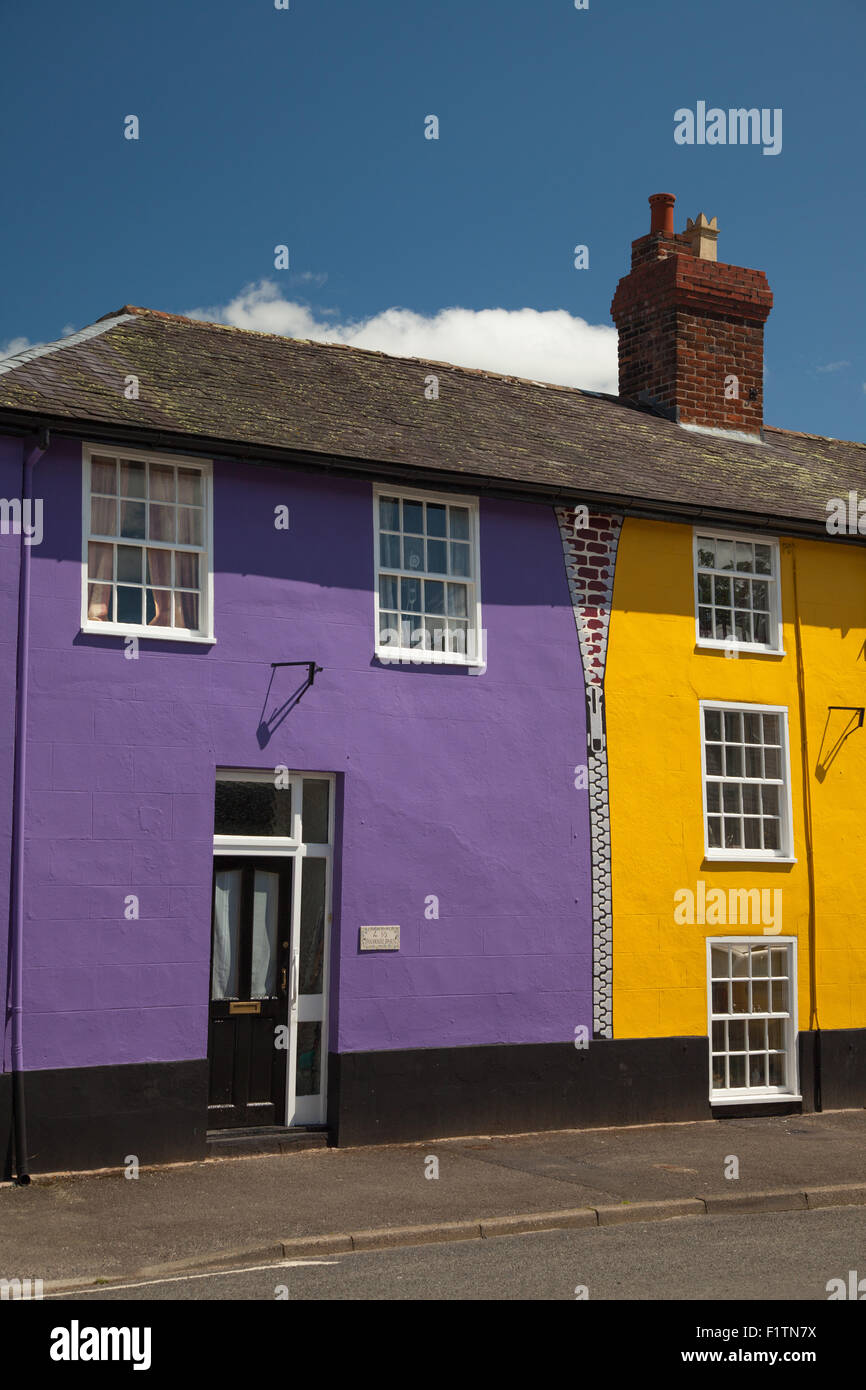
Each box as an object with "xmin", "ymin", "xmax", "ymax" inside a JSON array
[{"xmin": 0, "ymin": 1111, "xmax": 866, "ymax": 1293}]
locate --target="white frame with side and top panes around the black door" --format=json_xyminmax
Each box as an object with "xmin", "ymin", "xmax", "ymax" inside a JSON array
[{"xmin": 211, "ymin": 767, "xmax": 336, "ymax": 1126}]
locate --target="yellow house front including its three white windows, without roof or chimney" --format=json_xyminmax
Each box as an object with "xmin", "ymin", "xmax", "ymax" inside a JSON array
[{"xmin": 606, "ymin": 517, "xmax": 866, "ymax": 1102}]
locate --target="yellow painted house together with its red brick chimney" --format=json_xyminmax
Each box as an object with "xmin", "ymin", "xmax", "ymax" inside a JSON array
[{"xmin": 599, "ymin": 195, "xmax": 866, "ymax": 1113}]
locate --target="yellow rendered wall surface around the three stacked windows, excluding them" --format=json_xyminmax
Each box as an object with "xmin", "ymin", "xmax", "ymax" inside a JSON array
[{"xmin": 605, "ymin": 518, "xmax": 866, "ymax": 1037}]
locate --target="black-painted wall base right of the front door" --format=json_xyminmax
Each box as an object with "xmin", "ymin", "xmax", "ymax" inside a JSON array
[{"xmin": 328, "ymin": 1029, "xmax": 866, "ymax": 1147}]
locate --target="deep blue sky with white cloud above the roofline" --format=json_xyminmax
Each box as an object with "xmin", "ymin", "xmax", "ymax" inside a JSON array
[{"xmin": 0, "ymin": 0, "xmax": 866, "ymax": 439}]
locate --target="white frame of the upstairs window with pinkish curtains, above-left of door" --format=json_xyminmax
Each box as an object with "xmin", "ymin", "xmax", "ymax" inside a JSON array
[{"xmin": 81, "ymin": 443, "xmax": 217, "ymax": 646}]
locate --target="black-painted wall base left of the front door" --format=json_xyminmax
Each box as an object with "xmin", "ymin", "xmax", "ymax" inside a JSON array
[{"xmin": 0, "ymin": 1061, "xmax": 207, "ymax": 1180}]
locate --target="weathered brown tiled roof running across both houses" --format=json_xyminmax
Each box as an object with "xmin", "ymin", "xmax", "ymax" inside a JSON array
[{"xmin": 0, "ymin": 306, "xmax": 866, "ymax": 525}]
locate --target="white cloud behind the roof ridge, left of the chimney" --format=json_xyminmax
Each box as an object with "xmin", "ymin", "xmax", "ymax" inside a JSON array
[{"xmin": 189, "ymin": 279, "xmax": 617, "ymax": 392}]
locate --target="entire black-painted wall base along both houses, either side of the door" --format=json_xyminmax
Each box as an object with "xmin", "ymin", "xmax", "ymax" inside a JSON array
[{"xmin": 0, "ymin": 1029, "xmax": 866, "ymax": 1180}]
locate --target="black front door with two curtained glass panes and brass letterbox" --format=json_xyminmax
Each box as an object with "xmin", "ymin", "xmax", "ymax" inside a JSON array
[{"xmin": 207, "ymin": 856, "xmax": 292, "ymax": 1129}]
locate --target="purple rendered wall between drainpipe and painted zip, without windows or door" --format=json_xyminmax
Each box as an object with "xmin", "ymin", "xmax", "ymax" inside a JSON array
[{"xmin": 18, "ymin": 441, "xmax": 592, "ymax": 1069}]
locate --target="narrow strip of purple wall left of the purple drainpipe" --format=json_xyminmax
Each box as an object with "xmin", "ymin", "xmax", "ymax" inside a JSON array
[{"xmin": 0, "ymin": 435, "xmax": 24, "ymax": 1072}]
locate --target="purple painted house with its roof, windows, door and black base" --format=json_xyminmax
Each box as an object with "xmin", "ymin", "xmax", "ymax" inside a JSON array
[{"xmin": 0, "ymin": 309, "xmax": 619, "ymax": 1176}]
